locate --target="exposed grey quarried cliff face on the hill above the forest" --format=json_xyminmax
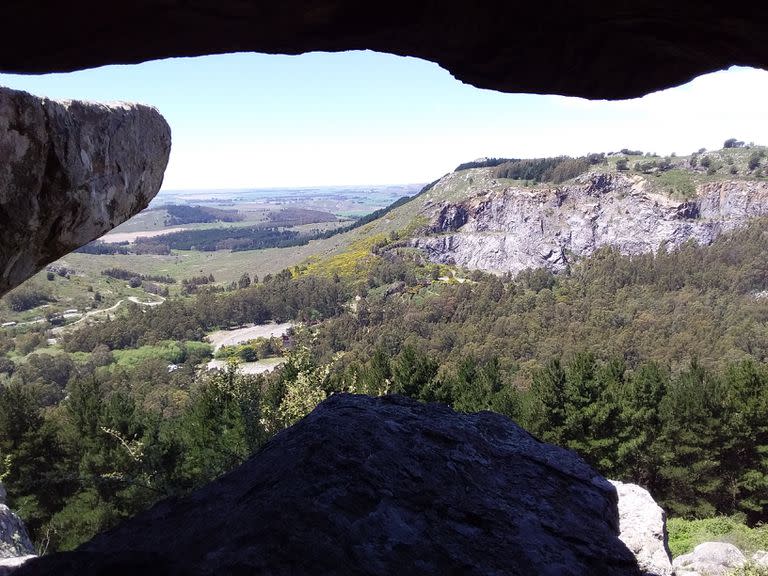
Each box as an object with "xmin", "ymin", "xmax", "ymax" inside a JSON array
[{"xmin": 411, "ymin": 173, "xmax": 768, "ymax": 273}]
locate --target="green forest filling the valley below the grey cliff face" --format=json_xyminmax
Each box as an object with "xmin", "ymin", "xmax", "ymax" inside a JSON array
[{"xmin": 0, "ymin": 221, "xmax": 768, "ymax": 550}]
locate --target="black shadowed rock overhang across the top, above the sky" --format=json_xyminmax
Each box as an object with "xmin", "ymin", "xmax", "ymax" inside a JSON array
[{"xmin": 0, "ymin": 0, "xmax": 768, "ymax": 98}]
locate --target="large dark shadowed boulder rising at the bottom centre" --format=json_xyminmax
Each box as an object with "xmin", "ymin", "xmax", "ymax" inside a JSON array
[{"xmin": 17, "ymin": 394, "xmax": 640, "ymax": 576}]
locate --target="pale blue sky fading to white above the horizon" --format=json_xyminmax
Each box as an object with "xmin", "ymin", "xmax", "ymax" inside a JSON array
[{"xmin": 0, "ymin": 52, "xmax": 768, "ymax": 189}]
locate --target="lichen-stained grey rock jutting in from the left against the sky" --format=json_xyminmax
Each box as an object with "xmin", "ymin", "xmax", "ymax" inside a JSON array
[{"xmin": 0, "ymin": 88, "xmax": 171, "ymax": 295}]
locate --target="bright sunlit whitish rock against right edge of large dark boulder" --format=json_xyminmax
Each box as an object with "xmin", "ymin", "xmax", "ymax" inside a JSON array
[{"xmin": 610, "ymin": 480, "xmax": 673, "ymax": 576}]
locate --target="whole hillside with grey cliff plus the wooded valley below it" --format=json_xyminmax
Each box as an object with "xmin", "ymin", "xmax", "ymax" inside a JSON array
[{"xmin": 0, "ymin": 147, "xmax": 768, "ymax": 550}]
